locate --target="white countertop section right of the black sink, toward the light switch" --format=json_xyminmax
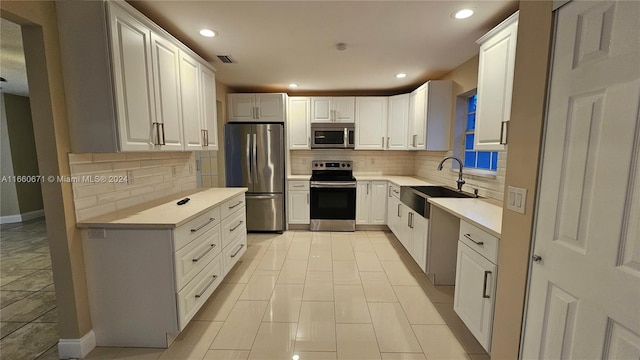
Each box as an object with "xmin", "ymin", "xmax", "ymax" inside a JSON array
[{"xmin": 428, "ymin": 198, "xmax": 502, "ymax": 238}]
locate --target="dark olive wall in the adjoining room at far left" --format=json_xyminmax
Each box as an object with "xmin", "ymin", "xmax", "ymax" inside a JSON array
[{"xmin": 4, "ymin": 94, "xmax": 43, "ymax": 214}]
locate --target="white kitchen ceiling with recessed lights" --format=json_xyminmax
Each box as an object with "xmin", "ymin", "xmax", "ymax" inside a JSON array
[{"xmin": 129, "ymin": 0, "xmax": 518, "ymax": 94}]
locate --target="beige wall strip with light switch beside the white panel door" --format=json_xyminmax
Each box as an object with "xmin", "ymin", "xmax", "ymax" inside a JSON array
[{"xmin": 491, "ymin": 0, "xmax": 552, "ymax": 359}]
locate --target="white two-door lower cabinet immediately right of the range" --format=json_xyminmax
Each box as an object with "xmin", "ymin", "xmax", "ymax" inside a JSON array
[{"xmin": 356, "ymin": 181, "xmax": 387, "ymax": 225}]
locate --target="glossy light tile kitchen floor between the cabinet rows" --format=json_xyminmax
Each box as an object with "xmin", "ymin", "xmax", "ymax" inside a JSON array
[{"xmin": 87, "ymin": 231, "xmax": 489, "ymax": 360}]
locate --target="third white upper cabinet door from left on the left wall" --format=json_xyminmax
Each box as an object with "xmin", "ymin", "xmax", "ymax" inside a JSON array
[{"xmin": 180, "ymin": 51, "xmax": 203, "ymax": 150}]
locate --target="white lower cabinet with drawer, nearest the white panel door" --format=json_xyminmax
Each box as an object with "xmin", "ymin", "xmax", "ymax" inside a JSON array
[{"xmin": 453, "ymin": 221, "xmax": 498, "ymax": 352}]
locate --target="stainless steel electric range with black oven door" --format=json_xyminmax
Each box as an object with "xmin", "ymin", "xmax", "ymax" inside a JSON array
[{"xmin": 310, "ymin": 160, "xmax": 356, "ymax": 231}]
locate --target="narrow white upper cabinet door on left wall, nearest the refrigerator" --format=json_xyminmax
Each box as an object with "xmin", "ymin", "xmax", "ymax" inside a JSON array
[{"xmin": 200, "ymin": 64, "xmax": 218, "ymax": 150}]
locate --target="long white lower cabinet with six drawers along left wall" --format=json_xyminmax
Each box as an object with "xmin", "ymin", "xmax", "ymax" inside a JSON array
[{"xmin": 82, "ymin": 194, "xmax": 247, "ymax": 348}]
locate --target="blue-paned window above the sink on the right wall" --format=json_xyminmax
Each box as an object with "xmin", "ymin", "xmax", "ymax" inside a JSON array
[{"xmin": 464, "ymin": 94, "xmax": 498, "ymax": 171}]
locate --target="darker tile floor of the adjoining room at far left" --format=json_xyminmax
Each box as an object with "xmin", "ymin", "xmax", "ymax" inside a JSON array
[{"xmin": 0, "ymin": 219, "xmax": 59, "ymax": 360}]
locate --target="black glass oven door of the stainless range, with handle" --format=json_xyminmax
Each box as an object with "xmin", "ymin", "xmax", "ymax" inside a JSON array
[{"xmin": 309, "ymin": 181, "xmax": 356, "ymax": 221}]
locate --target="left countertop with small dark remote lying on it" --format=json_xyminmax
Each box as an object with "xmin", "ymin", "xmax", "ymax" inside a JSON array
[{"xmin": 76, "ymin": 188, "xmax": 248, "ymax": 228}]
